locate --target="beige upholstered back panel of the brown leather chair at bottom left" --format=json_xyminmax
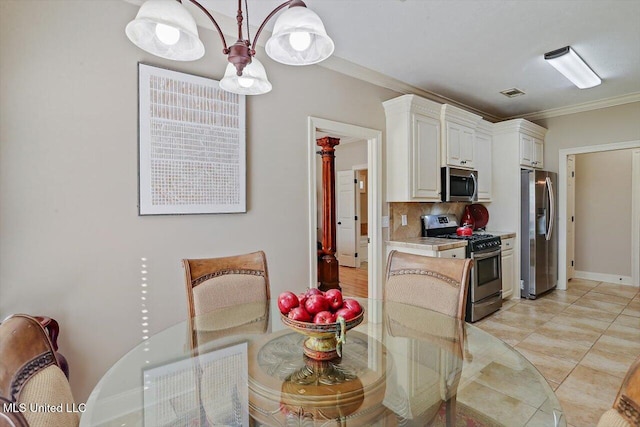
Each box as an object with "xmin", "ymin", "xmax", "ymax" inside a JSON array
[{"xmin": 18, "ymin": 366, "xmax": 80, "ymax": 427}]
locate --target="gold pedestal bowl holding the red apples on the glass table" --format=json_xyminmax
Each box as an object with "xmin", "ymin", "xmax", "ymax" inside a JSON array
[{"xmin": 280, "ymin": 309, "xmax": 364, "ymax": 360}]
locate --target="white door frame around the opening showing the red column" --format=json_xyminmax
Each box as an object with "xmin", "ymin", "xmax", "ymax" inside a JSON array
[{"xmin": 308, "ymin": 117, "xmax": 383, "ymax": 299}]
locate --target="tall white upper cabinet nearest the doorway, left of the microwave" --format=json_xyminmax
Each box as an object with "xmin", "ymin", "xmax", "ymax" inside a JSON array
[{"xmin": 383, "ymin": 95, "xmax": 441, "ymax": 202}]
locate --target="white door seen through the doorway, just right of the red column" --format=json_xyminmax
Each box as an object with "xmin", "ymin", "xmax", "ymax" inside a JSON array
[{"xmin": 336, "ymin": 170, "xmax": 359, "ymax": 267}]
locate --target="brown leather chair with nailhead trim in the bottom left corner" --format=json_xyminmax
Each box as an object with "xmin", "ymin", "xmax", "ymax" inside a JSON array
[{"xmin": 0, "ymin": 314, "xmax": 80, "ymax": 427}]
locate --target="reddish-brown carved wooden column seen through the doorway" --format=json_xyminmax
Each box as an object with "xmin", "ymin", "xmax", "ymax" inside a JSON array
[{"xmin": 316, "ymin": 136, "xmax": 340, "ymax": 291}]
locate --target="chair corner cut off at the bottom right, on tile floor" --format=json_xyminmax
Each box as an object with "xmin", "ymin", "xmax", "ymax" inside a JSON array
[{"xmin": 598, "ymin": 356, "xmax": 640, "ymax": 427}]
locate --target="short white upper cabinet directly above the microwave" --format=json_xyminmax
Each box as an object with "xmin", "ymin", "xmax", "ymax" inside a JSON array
[{"xmin": 441, "ymin": 104, "xmax": 482, "ymax": 169}]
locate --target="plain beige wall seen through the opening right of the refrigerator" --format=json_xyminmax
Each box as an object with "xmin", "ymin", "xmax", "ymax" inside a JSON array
[{"xmin": 575, "ymin": 150, "xmax": 633, "ymax": 276}]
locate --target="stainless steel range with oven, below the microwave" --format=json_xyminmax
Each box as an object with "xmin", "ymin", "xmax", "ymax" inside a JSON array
[{"xmin": 421, "ymin": 214, "xmax": 502, "ymax": 322}]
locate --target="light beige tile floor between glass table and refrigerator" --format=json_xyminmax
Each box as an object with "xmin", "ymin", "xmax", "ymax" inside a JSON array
[{"xmin": 475, "ymin": 279, "xmax": 640, "ymax": 427}]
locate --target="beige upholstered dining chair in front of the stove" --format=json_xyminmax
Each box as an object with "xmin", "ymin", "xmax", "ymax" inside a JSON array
[{"xmin": 384, "ymin": 251, "xmax": 473, "ymax": 426}]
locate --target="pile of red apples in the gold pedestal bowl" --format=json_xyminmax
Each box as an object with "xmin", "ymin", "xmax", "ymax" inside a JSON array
[{"xmin": 278, "ymin": 288, "xmax": 362, "ymax": 324}]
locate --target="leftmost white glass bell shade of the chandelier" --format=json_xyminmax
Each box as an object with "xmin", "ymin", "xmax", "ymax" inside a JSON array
[{"xmin": 125, "ymin": 0, "xmax": 204, "ymax": 61}]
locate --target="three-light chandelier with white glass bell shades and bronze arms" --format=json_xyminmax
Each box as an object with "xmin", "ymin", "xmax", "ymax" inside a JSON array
[{"xmin": 125, "ymin": 0, "xmax": 334, "ymax": 95}]
